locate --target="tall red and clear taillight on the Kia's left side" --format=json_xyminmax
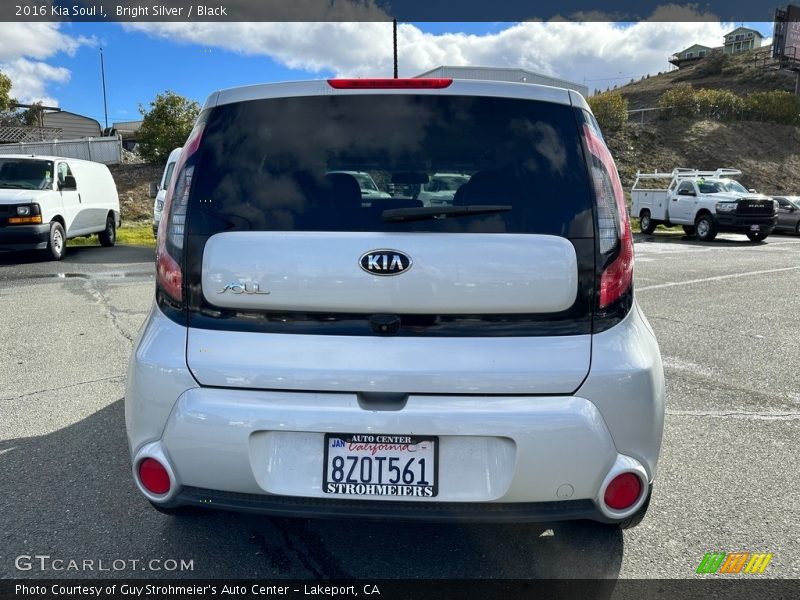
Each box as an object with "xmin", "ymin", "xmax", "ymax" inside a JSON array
[{"xmin": 156, "ymin": 115, "xmax": 205, "ymax": 304}]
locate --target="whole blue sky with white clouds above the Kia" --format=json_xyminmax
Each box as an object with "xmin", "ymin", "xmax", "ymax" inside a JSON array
[{"xmin": 0, "ymin": 23, "xmax": 772, "ymax": 125}]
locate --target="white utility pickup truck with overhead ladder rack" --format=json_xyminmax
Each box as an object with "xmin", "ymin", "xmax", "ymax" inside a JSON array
[{"xmin": 631, "ymin": 169, "xmax": 778, "ymax": 242}]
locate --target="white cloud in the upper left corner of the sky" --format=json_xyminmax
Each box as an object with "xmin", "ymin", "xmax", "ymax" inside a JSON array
[{"xmin": 0, "ymin": 23, "xmax": 96, "ymax": 106}]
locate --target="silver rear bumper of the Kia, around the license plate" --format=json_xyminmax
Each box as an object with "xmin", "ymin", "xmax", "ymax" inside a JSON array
[{"xmin": 125, "ymin": 307, "xmax": 664, "ymax": 521}]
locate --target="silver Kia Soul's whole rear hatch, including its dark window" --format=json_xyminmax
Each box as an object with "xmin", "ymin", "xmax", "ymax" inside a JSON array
[{"xmin": 166, "ymin": 82, "xmax": 596, "ymax": 394}]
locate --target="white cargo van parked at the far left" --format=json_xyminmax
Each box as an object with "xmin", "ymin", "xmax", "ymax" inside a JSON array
[{"xmin": 0, "ymin": 154, "xmax": 120, "ymax": 260}]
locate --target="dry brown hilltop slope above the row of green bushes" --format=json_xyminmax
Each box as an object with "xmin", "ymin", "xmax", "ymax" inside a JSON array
[{"xmin": 615, "ymin": 48, "xmax": 795, "ymax": 109}]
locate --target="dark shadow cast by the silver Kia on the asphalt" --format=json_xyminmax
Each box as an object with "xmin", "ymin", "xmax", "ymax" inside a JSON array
[{"xmin": 0, "ymin": 397, "xmax": 623, "ymax": 587}]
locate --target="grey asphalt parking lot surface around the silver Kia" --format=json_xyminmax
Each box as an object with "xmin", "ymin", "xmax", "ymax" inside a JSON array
[{"xmin": 0, "ymin": 234, "xmax": 800, "ymax": 579}]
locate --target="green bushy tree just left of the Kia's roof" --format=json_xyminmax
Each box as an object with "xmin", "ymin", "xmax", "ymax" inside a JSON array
[{"xmin": 139, "ymin": 90, "xmax": 200, "ymax": 162}]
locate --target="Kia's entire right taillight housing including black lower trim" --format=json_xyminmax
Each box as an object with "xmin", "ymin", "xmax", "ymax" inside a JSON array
[{"xmin": 582, "ymin": 115, "xmax": 633, "ymax": 333}]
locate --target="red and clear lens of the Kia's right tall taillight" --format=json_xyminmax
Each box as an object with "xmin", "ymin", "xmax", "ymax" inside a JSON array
[{"xmin": 583, "ymin": 123, "xmax": 633, "ymax": 308}]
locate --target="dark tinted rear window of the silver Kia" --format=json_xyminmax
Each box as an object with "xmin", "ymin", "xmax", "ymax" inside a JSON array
[{"xmin": 188, "ymin": 95, "xmax": 593, "ymax": 237}]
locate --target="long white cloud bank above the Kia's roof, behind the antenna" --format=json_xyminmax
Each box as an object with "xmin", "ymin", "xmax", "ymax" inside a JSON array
[{"xmin": 123, "ymin": 12, "xmax": 752, "ymax": 88}]
